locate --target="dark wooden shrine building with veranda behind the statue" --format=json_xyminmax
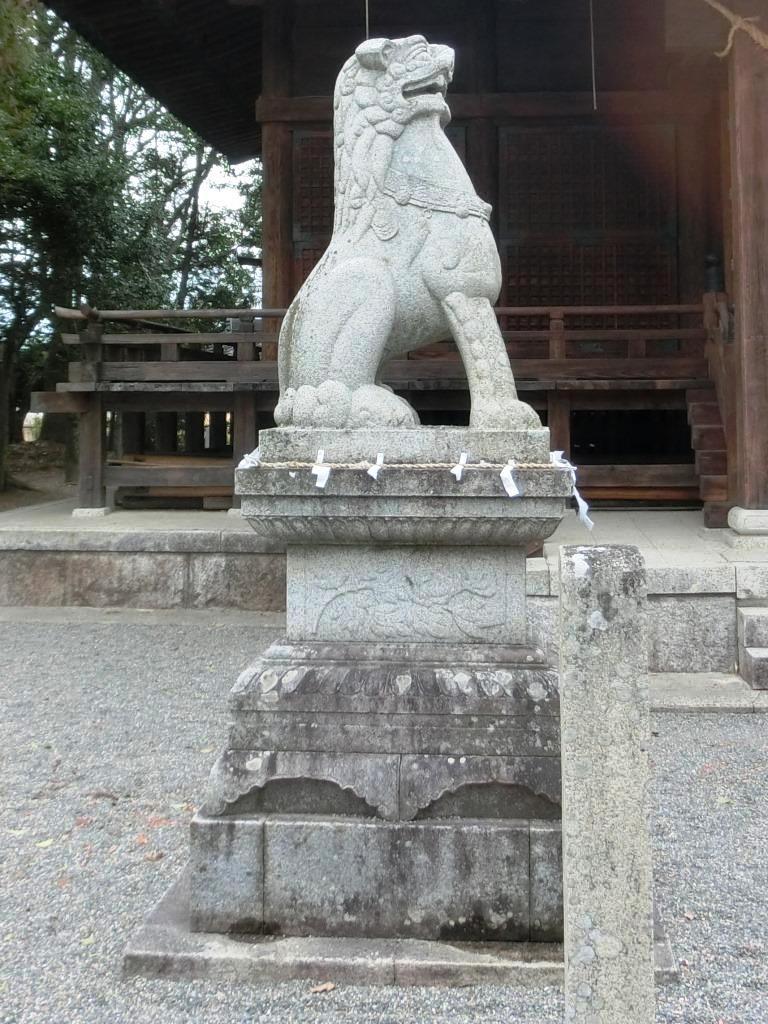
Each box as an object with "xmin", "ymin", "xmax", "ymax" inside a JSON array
[{"xmin": 38, "ymin": 0, "xmax": 768, "ymax": 524}]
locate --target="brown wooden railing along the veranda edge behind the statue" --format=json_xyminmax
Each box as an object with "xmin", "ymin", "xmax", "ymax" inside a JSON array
[{"xmin": 56, "ymin": 303, "xmax": 707, "ymax": 387}]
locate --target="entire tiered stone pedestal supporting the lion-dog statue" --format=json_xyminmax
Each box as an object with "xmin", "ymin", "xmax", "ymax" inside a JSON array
[{"xmin": 190, "ymin": 428, "xmax": 571, "ymax": 941}]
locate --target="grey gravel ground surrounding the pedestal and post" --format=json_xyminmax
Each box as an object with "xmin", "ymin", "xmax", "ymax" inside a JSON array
[{"xmin": 0, "ymin": 612, "xmax": 768, "ymax": 1024}]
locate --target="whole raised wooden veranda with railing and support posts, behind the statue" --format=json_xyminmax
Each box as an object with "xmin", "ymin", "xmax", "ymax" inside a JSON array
[{"xmin": 36, "ymin": 298, "xmax": 716, "ymax": 505}]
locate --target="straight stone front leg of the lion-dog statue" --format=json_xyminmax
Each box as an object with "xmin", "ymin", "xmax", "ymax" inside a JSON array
[{"xmin": 442, "ymin": 292, "xmax": 542, "ymax": 430}]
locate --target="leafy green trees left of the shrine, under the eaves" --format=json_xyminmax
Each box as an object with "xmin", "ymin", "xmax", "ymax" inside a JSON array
[{"xmin": 0, "ymin": 0, "xmax": 260, "ymax": 488}]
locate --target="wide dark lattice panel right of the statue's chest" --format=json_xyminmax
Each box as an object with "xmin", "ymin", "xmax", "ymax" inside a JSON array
[{"xmin": 499, "ymin": 126, "xmax": 678, "ymax": 327}]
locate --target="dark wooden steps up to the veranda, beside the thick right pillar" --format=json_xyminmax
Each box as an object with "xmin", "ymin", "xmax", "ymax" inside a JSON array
[{"xmin": 685, "ymin": 386, "xmax": 729, "ymax": 528}]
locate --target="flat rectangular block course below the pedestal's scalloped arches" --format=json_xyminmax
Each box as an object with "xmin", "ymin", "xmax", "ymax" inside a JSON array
[{"xmin": 190, "ymin": 815, "xmax": 562, "ymax": 942}]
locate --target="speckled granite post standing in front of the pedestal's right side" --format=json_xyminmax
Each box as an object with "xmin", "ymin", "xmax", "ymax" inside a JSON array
[{"xmin": 560, "ymin": 546, "xmax": 655, "ymax": 1024}]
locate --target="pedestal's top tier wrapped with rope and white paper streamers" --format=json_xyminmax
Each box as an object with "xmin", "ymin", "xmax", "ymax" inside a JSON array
[{"xmin": 236, "ymin": 427, "xmax": 571, "ymax": 548}]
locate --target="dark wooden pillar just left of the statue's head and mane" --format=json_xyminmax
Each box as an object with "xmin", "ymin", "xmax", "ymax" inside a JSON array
[{"xmin": 261, "ymin": 0, "xmax": 293, "ymax": 359}]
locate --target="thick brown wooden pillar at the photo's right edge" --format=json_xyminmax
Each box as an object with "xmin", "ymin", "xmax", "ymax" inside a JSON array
[{"xmin": 729, "ymin": 32, "xmax": 768, "ymax": 509}]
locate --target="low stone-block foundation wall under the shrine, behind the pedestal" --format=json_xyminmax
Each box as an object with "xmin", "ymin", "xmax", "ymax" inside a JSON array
[{"xmin": 0, "ymin": 530, "xmax": 745, "ymax": 672}]
